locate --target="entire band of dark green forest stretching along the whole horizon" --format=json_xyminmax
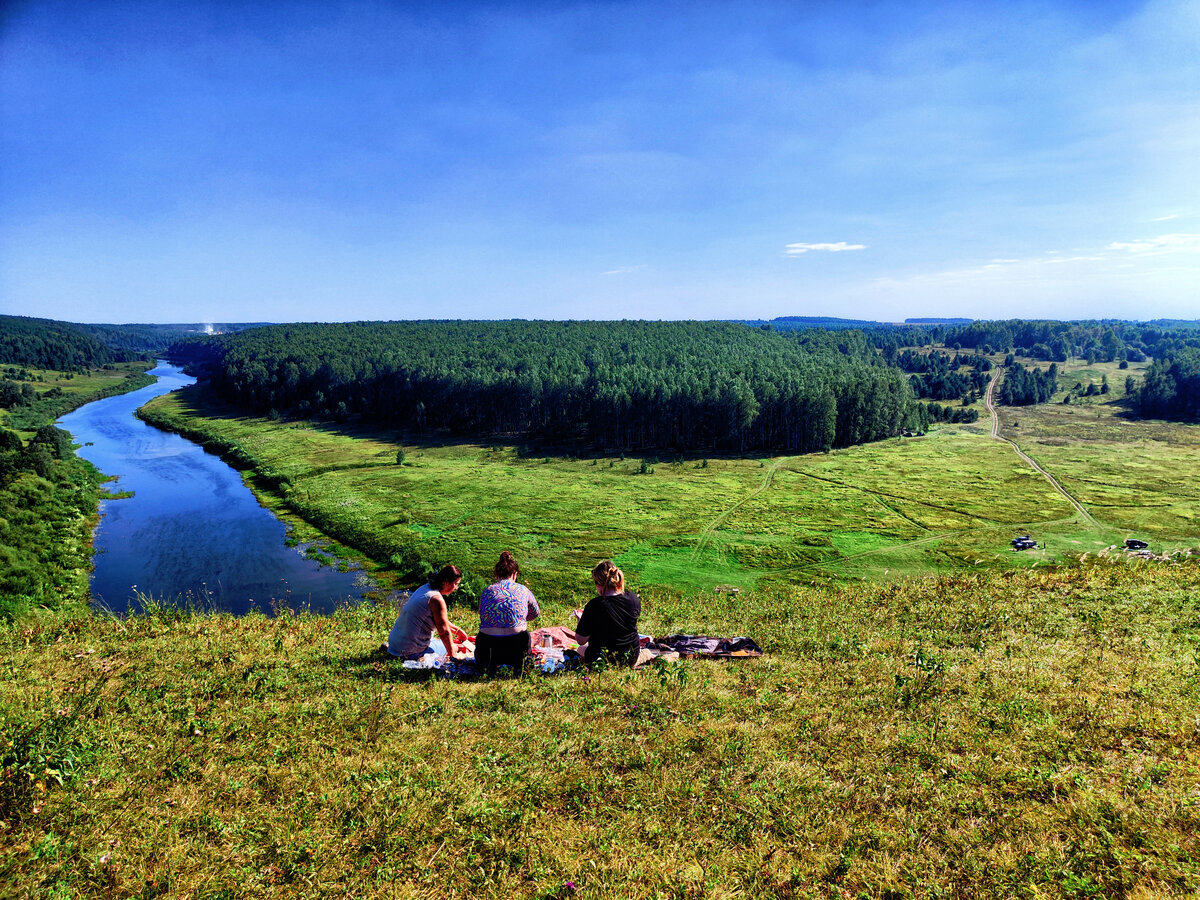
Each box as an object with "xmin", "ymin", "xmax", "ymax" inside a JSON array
[{"xmin": 0, "ymin": 316, "xmax": 1200, "ymax": 452}]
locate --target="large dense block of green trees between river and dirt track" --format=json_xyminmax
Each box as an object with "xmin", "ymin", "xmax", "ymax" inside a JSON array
[{"xmin": 175, "ymin": 322, "xmax": 917, "ymax": 452}]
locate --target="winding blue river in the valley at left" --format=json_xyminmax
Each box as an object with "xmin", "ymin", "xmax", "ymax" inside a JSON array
[{"xmin": 58, "ymin": 362, "xmax": 371, "ymax": 614}]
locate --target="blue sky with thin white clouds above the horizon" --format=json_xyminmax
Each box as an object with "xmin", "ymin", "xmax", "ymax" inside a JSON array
[{"xmin": 0, "ymin": 0, "xmax": 1200, "ymax": 322}]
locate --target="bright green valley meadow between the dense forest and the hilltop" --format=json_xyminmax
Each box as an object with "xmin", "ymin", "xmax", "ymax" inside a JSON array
[{"xmin": 136, "ymin": 355, "xmax": 1200, "ymax": 604}]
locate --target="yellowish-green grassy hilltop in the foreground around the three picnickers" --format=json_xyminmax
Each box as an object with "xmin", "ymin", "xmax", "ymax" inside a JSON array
[{"xmin": 0, "ymin": 564, "xmax": 1200, "ymax": 900}]
